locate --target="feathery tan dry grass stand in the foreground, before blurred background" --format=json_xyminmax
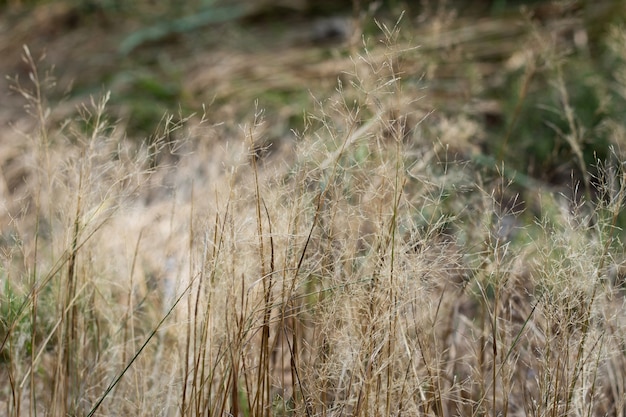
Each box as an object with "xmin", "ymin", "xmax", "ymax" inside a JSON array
[{"xmin": 0, "ymin": 11, "xmax": 626, "ymax": 417}]
